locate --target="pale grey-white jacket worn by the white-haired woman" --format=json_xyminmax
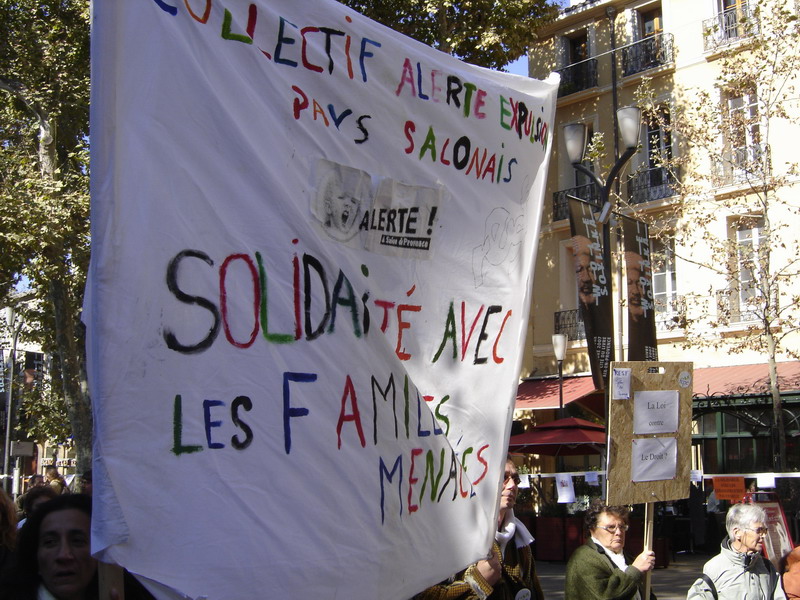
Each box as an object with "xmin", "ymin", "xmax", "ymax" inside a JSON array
[{"xmin": 686, "ymin": 538, "xmax": 786, "ymax": 600}]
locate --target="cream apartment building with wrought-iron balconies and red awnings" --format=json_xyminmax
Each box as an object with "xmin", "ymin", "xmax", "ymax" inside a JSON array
[{"xmin": 516, "ymin": 0, "xmax": 800, "ymax": 481}]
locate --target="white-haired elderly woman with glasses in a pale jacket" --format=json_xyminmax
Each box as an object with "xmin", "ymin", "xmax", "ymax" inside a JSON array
[{"xmin": 686, "ymin": 504, "xmax": 786, "ymax": 600}]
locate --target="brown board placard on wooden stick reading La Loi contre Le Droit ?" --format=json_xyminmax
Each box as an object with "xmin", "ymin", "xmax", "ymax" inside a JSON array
[{"xmin": 606, "ymin": 361, "xmax": 694, "ymax": 600}]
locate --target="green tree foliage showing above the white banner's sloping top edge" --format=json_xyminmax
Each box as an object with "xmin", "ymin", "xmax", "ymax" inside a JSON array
[{"xmin": 343, "ymin": 0, "xmax": 558, "ymax": 69}]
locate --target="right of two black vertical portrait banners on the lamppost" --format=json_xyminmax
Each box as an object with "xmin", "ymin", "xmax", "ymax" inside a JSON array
[{"xmin": 622, "ymin": 217, "xmax": 658, "ymax": 361}]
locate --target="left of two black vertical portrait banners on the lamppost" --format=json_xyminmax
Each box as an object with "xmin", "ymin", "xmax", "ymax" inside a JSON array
[{"xmin": 569, "ymin": 198, "xmax": 614, "ymax": 390}]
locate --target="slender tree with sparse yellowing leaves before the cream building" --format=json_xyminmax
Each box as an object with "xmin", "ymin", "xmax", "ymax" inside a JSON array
[{"xmin": 631, "ymin": 0, "xmax": 800, "ymax": 471}]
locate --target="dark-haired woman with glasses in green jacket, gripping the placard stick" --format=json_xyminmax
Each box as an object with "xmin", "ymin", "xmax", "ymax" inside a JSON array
[{"xmin": 564, "ymin": 503, "xmax": 656, "ymax": 600}]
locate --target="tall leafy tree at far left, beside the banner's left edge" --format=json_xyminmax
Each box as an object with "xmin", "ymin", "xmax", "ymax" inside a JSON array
[{"xmin": 0, "ymin": 0, "xmax": 92, "ymax": 470}]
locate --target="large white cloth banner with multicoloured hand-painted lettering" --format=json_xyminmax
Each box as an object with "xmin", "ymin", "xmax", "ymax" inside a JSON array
[{"xmin": 84, "ymin": 0, "xmax": 558, "ymax": 600}]
